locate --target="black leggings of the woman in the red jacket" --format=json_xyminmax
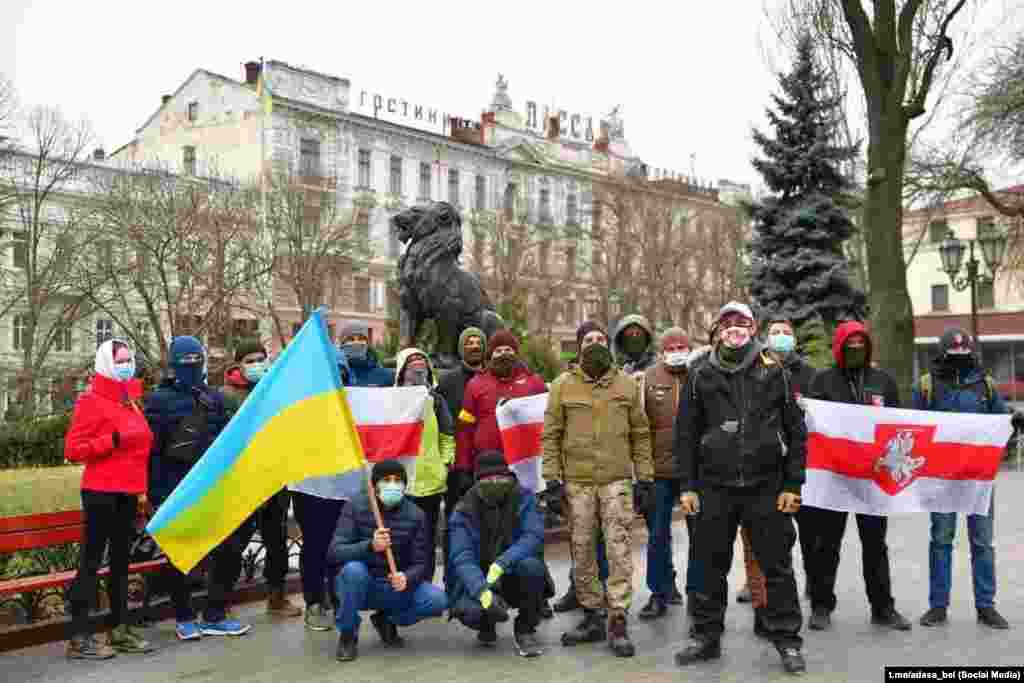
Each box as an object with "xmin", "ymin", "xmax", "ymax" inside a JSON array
[{"xmin": 70, "ymin": 489, "xmax": 137, "ymax": 636}]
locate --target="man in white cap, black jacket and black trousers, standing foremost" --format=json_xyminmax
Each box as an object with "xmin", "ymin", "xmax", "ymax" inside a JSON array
[{"xmin": 674, "ymin": 302, "xmax": 807, "ymax": 673}]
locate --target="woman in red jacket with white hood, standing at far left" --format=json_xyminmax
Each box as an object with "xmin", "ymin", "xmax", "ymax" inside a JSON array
[{"xmin": 65, "ymin": 339, "xmax": 153, "ymax": 659}]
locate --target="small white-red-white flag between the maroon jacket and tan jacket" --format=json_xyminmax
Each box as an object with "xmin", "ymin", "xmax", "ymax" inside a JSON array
[{"xmin": 497, "ymin": 393, "xmax": 548, "ymax": 494}]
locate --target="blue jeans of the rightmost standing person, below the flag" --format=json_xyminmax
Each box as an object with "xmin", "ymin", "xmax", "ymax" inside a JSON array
[{"xmin": 928, "ymin": 496, "xmax": 995, "ymax": 609}]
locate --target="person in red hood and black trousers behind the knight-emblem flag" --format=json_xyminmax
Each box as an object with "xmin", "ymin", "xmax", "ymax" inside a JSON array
[{"xmin": 800, "ymin": 321, "xmax": 910, "ymax": 631}]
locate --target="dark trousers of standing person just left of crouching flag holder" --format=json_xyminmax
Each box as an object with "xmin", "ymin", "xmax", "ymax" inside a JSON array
[{"xmin": 292, "ymin": 492, "xmax": 345, "ymax": 606}]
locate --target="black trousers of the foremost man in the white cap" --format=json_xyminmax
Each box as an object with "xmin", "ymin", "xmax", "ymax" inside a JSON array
[{"xmin": 693, "ymin": 486, "xmax": 803, "ymax": 649}]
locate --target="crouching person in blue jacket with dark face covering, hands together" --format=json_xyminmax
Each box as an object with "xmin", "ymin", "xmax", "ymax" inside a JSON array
[{"xmin": 449, "ymin": 451, "xmax": 551, "ymax": 657}]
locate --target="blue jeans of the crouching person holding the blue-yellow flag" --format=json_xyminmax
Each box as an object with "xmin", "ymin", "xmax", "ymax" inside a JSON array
[{"xmin": 335, "ymin": 561, "xmax": 447, "ymax": 634}]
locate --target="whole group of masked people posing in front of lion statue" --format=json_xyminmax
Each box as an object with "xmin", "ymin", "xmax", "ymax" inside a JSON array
[{"xmin": 59, "ymin": 302, "xmax": 1024, "ymax": 673}]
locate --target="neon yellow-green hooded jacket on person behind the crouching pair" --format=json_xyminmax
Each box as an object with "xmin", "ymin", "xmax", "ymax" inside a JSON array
[{"xmin": 394, "ymin": 348, "xmax": 455, "ymax": 498}]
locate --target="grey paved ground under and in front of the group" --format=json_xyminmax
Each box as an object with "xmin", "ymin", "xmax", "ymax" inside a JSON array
[{"xmin": 0, "ymin": 470, "xmax": 1024, "ymax": 683}]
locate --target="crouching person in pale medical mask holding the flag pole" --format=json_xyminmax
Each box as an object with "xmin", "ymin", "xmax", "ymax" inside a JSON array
[{"xmin": 328, "ymin": 461, "xmax": 447, "ymax": 661}]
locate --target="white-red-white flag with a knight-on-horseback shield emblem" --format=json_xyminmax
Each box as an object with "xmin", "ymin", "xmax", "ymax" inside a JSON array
[{"xmin": 803, "ymin": 399, "xmax": 1013, "ymax": 515}]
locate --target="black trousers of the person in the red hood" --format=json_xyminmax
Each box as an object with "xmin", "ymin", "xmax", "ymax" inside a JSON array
[{"xmin": 802, "ymin": 507, "xmax": 893, "ymax": 613}]
